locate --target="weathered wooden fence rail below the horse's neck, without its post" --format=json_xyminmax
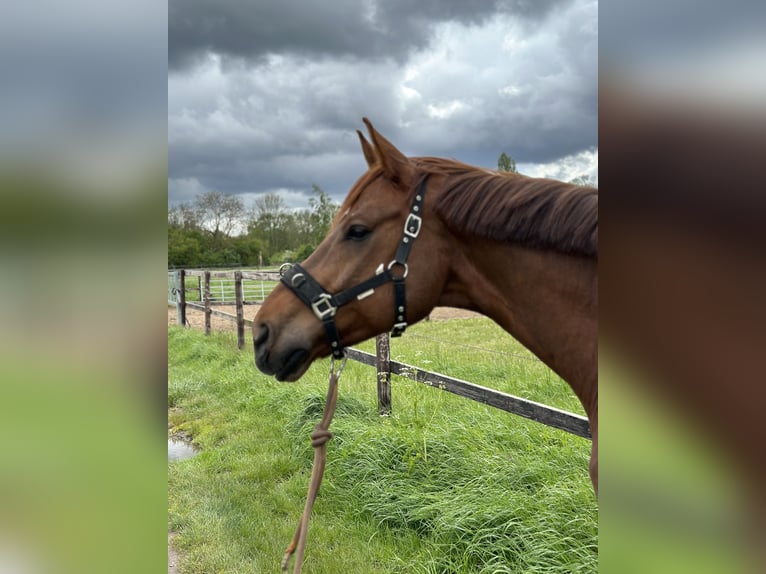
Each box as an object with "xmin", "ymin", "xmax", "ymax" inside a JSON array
[{"xmin": 346, "ymin": 349, "xmax": 591, "ymax": 438}]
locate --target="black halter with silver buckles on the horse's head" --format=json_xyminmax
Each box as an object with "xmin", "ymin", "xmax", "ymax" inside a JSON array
[{"xmin": 279, "ymin": 175, "xmax": 428, "ymax": 359}]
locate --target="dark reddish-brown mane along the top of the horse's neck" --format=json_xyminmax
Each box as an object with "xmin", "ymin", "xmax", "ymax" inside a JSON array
[{"xmin": 410, "ymin": 157, "xmax": 598, "ymax": 259}]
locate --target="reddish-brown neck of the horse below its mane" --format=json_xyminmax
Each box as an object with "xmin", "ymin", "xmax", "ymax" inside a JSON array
[{"xmin": 440, "ymin": 241, "xmax": 598, "ymax": 418}]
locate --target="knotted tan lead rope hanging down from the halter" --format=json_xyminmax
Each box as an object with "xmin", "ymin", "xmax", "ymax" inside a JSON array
[{"xmin": 282, "ymin": 353, "xmax": 348, "ymax": 574}]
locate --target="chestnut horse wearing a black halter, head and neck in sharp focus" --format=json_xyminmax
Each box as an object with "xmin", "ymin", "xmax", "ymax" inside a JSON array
[{"xmin": 253, "ymin": 118, "xmax": 598, "ymax": 492}]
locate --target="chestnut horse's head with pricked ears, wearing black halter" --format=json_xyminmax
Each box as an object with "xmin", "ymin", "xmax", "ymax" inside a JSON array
[{"xmin": 253, "ymin": 118, "xmax": 450, "ymax": 381}]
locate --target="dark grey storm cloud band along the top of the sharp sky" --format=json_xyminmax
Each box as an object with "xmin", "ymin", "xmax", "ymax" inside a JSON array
[{"xmin": 168, "ymin": 0, "xmax": 559, "ymax": 69}]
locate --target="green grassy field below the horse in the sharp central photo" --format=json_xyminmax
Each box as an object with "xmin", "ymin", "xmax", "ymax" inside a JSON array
[{"xmin": 168, "ymin": 319, "xmax": 598, "ymax": 574}]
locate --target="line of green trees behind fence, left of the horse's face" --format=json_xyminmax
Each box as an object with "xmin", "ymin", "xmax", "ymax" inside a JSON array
[{"xmin": 168, "ymin": 185, "xmax": 339, "ymax": 268}]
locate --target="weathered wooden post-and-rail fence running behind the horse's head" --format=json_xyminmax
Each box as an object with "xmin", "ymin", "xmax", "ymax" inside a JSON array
[{"xmin": 168, "ymin": 270, "xmax": 591, "ymax": 438}]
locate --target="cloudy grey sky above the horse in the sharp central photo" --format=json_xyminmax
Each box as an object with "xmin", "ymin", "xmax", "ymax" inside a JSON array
[{"xmin": 168, "ymin": 0, "xmax": 598, "ymax": 212}]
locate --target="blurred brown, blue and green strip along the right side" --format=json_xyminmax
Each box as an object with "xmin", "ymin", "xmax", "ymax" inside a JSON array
[{"xmin": 599, "ymin": 1, "xmax": 766, "ymax": 572}]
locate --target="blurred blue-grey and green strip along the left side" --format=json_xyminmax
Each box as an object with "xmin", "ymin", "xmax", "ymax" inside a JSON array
[{"xmin": 0, "ymin": 0, "xmax": 167, "ymax": 574}]
